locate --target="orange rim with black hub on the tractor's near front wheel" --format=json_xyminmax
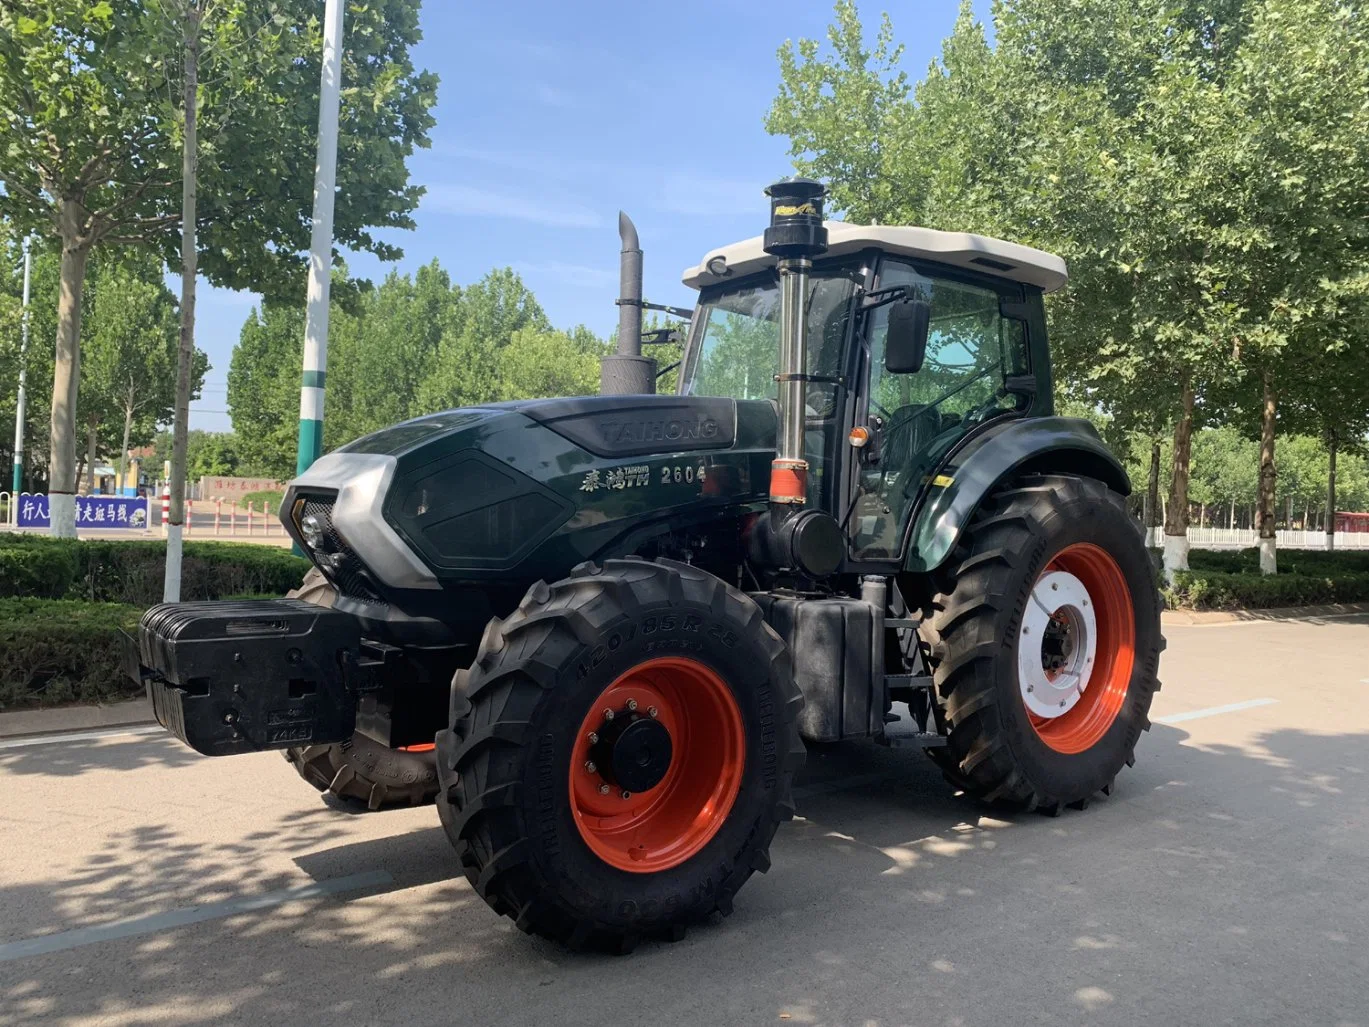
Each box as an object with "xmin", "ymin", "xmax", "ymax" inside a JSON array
[{"xmin": 570, "ymin": 656, "xmax": 746, "ymax": 874}]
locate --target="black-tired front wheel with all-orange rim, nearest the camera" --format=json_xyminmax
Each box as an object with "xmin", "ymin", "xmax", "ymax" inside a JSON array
[{"xmin": 438, "ymin": 560, "xmax": 804, "ymax": 952}]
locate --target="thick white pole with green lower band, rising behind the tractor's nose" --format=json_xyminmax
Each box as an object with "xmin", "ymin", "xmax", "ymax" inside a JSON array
[{"xmin": 296, "ymin": 0, "xmax": 342, "ymax": 474}]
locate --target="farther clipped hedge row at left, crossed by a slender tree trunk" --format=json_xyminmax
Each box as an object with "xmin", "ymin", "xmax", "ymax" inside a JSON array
[{"xmin": 0, "ymin": 533, "xmax": 309, "ymax": 607}]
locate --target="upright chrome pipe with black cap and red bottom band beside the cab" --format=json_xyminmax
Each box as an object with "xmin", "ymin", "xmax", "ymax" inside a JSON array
[{"xmin": 763, "ymin": 178, "xmax": 827, "ymax": 505}]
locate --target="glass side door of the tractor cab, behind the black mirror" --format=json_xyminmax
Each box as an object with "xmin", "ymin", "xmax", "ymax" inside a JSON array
[{"xmin": 846, "ymin": 259, "xmax": 1031, "ymax": 561}]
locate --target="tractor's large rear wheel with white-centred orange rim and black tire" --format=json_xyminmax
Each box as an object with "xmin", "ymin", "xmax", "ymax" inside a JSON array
[{"xmin": 924, "ymin": 475, "xmax": 1164, "ymax": 813}]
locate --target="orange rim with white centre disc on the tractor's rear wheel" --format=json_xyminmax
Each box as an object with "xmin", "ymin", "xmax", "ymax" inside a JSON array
[{"xmin": 1017, "ymin": 542, "xmax": 1136, "ymax": 753}]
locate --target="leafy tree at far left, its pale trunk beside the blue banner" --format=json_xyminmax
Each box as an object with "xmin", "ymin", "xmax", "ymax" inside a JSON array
[{"xmin": 0, "ymin": 0, "xmax": 435, "ymax": 534}]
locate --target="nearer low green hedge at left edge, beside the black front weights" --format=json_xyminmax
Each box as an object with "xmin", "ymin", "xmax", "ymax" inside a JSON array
[{"xmin": 0, "ymin": 598, "xmax": 142, "ymax": 709}]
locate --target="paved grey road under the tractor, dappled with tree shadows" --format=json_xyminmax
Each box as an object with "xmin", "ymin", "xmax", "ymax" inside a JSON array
[{"xmin": 0, "ymin": 616, "xmax": 1369, "ymax": 1027}]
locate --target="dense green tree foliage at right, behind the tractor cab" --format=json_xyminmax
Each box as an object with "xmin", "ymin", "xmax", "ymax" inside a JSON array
[{"xmin": 767, "ymin": 0, "xmax": 1369, "ymax": 564}]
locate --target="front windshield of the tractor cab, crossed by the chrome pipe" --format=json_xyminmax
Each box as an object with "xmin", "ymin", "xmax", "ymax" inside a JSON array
[{"xmin": 679, "ymin": 267, "xmax": 862, "ymax": 416}]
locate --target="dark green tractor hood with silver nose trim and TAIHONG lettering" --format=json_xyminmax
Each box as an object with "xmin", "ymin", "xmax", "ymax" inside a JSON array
[{"xmin": 281, "ymin": 396, "xmax": 776, "ymax": 603}]
